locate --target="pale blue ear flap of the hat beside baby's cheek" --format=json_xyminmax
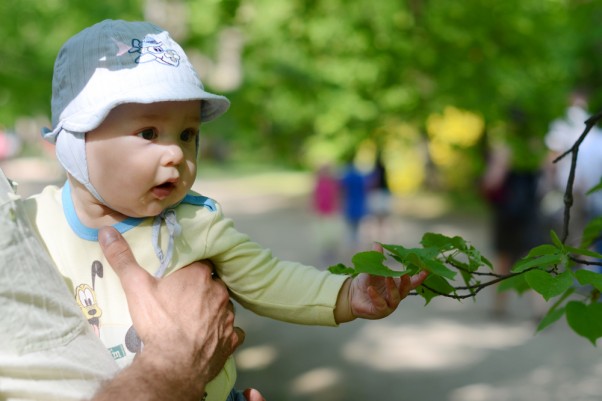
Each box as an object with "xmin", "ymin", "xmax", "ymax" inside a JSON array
[{"xmin": 56, "ymin": 129, "xmax": 105, "ymax": 203}]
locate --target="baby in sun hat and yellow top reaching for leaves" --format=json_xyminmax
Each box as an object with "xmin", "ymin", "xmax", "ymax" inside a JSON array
[{"xmin": 27, "ymin": 20, "xmax": 425, "ymax": 401}]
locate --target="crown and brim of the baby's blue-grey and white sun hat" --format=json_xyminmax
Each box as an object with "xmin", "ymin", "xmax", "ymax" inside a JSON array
[{"xmin": 44, "ymin": 20, "xmax": 230, "ymax": 142}]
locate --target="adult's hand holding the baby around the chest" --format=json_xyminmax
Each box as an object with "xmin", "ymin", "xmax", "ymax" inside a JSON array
[{"xmin": 98, "ymin": 227, "xmax": 244, "ymax": 400}]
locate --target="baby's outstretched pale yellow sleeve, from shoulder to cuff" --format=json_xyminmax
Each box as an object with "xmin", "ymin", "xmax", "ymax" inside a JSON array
[{"xmin": 178, "ymin": 202, "xmax": 347, "ymax": 326}]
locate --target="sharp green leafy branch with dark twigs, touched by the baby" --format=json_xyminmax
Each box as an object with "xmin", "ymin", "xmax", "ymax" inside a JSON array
[{"xmin": 330, "ymin": 112, "xmax": 602, "ymax": 345}]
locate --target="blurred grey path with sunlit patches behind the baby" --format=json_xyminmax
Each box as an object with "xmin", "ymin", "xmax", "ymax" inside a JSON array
[{"xmin": 8, "ymin": 163, "xmax": 602, "ymax": 401}]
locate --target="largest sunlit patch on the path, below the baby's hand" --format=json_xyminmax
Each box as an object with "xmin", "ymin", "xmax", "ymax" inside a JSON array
[{"xmin": 343, "ymin": 319, "xmax": 533, "ymax": 371}]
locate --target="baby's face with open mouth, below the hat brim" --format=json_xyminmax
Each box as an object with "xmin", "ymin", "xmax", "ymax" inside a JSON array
[{"xmin": 86, "ymin": 100, "xmax": 201, "ymax": 217}]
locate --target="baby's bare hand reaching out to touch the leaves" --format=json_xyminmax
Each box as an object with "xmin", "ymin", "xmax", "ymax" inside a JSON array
[{"xmin": 334, "ymin": 245, "xmax": 427, "ymax": 323}]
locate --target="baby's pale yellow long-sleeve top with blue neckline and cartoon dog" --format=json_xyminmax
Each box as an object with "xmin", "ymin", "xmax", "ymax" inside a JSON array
[{"xmin": 25, "ymin": 184, "xmax": 346, "ymax": 401}]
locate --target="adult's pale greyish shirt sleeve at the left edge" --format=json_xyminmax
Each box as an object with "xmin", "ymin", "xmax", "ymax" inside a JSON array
[{"xmin": 0, "ymin": 183, "xmax": 117, "ymax": 401}]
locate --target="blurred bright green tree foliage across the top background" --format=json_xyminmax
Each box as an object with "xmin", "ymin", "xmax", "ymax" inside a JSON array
[{"xmin": 0, "ymin": 0, "xmax": 602, "ymax": 170}]
